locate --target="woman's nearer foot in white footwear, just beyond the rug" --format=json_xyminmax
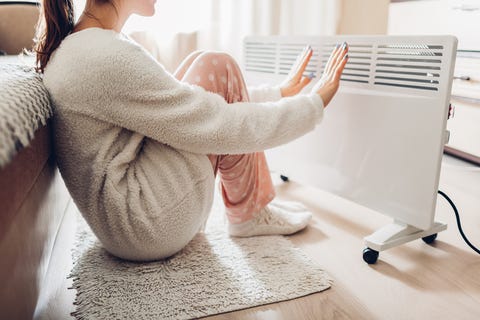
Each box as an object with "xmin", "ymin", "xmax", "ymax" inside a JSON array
[{"xmin": 228, "ymin": 201, "xmax": 312, "ymax": 237}]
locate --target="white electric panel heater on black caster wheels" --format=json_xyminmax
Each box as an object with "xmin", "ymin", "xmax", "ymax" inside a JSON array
[{"xmin": 243, "ymin": 36, "xmax": 457, "ymax": 263}]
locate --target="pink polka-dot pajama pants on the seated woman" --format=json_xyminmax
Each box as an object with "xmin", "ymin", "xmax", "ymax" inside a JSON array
[{"xmin": 175, "ymin": 52, "xmax": 275, "ymax": 223}]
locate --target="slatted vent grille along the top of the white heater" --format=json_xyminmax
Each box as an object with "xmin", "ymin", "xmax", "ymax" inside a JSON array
[{"xmin": 244, "ymin": 37, "xmax": 445, "ymax": 91}]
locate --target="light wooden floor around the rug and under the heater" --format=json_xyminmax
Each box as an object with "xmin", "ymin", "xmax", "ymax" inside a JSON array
[{"xmin": 41, "ymin": 157, "xmax": 480, "ymax": 320}]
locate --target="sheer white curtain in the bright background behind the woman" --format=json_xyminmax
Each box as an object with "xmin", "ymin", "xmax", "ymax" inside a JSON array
[{"xmin": 77, "ymin": 0, "xmax": 342, "ymax": 70}]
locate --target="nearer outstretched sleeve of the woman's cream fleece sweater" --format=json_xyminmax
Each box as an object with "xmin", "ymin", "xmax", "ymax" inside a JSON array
[{"xmin": 77, "ymin": 40, "xmax": 323, "ymax": 154}]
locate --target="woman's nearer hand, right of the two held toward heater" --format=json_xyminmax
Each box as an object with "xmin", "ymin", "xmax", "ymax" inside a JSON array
[{"xmin": 312, "ymin": 42, "xmax": 348, "ymax": 107}]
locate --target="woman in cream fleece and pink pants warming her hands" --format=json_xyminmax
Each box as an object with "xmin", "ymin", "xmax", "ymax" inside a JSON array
[{"xmin": 37, "ymin": 0, "xmax": 348, "ymax": 261}]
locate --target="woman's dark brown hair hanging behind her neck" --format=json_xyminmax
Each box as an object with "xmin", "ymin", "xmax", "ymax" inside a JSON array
[{"xmin": 34, "ymin": 0, "xmax": 75, "ymax": 72}]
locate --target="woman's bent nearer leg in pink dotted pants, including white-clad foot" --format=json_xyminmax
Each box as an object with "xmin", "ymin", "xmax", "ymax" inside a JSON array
[{"xmin": 176, "ymin": 52, "xmax": 310, "ymax": 236}]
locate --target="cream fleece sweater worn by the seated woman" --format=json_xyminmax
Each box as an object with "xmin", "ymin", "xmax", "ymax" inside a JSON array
[{"xmin": 43, "ymin": 28, "xmax": 323, "ymax": 260}]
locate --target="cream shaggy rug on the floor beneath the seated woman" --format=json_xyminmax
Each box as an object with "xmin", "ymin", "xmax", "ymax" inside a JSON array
[{"xmin": 70, "ymin": 199, "xmax": 331, "ymax": 319}]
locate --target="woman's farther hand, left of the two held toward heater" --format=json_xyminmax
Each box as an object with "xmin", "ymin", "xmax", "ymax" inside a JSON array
[{"xmin": 280, "ymin": 46, "xmax": 313, "ymax": 97}]
